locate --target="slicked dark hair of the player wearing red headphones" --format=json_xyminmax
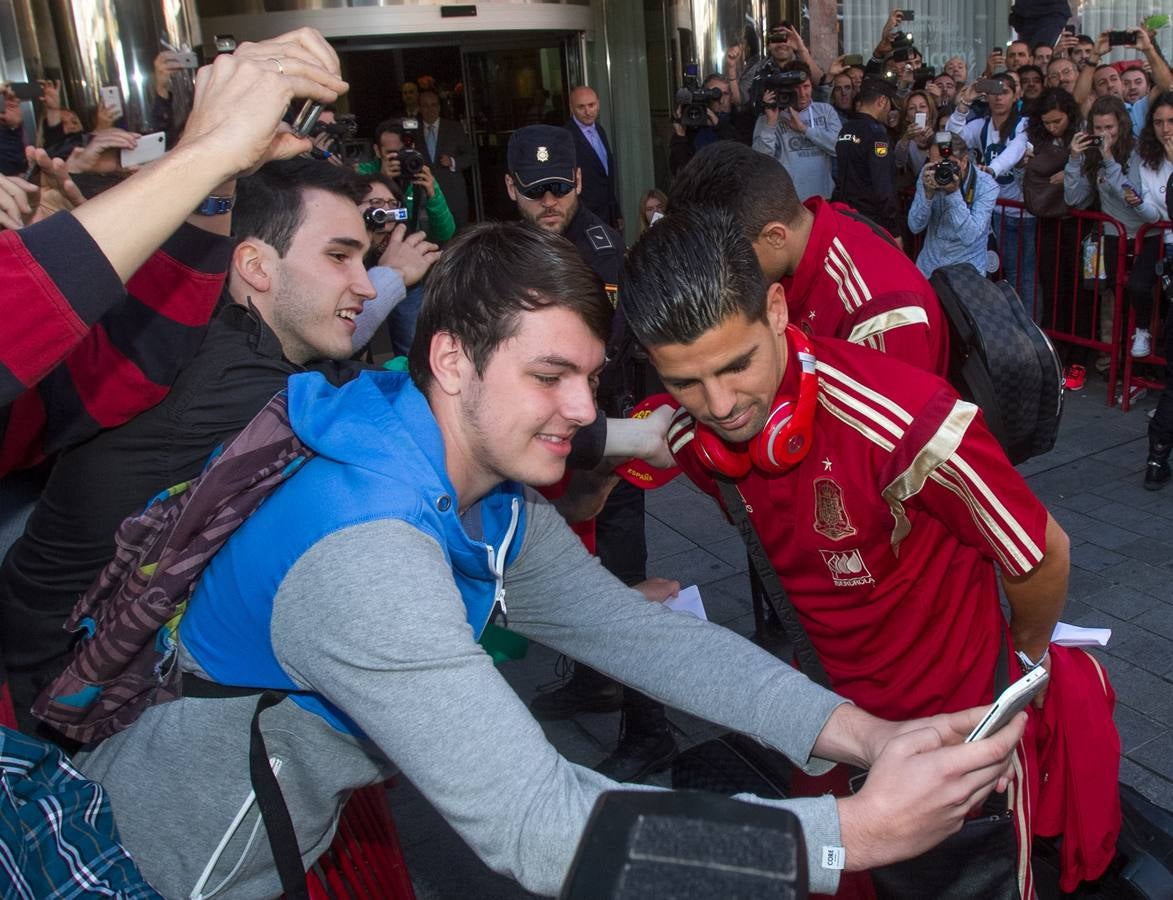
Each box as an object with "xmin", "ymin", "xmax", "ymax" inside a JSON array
[{"xmin": 619, "ymin": 207, "xmax": 767, "ymax": 347}]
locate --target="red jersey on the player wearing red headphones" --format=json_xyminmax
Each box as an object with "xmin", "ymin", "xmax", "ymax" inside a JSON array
[{"xmin": 677, "ymin": 339, "xmax": 1047, "ymax": 719}]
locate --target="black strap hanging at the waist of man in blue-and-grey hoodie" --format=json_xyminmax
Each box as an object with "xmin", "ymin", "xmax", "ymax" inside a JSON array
[{"xmin": 183, "ymin": 672, "xmax": 310, "ymax": 900}]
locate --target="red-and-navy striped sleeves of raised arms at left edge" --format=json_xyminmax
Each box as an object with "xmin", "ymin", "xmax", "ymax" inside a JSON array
[{"xmin": 0, "ymin": 214, "xmax": 233, "ymax": 476}]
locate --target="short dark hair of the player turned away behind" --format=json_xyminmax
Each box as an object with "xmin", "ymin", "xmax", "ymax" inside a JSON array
[{"xmin": 667, "ymin": 141, "xmax": 802, "ymax": 241}]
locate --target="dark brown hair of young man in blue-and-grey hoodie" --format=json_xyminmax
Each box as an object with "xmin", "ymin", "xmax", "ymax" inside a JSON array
[{"xmin": 408, "ymin": 222, "xmax": 612, "ymax": 391}]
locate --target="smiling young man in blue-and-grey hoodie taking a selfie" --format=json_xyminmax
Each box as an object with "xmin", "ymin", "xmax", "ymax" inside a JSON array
[{"xmin": 81, "ymin": 224, "xmax": 1023, "ymax": 896}]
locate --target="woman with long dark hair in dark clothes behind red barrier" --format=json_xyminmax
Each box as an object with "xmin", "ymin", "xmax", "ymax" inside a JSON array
[{"xmin": 1023, "ymin": 88, "xmax": 1091, "ymax": 344}]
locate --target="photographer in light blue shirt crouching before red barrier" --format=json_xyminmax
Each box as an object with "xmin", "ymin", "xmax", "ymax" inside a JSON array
[{"xmin": 908, "ymin": 131, "xmax": 998, "ymax": 278}]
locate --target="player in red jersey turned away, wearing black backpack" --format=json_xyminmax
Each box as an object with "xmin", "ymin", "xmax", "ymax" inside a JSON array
[{"xmin": 669, "ymin": 141, "xmax": 949, "ymax": 375}]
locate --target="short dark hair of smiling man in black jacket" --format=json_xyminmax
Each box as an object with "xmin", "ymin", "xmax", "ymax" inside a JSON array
[{"xmin": 232, "ymin": 157, "xmax": 366, "ymax": 257}]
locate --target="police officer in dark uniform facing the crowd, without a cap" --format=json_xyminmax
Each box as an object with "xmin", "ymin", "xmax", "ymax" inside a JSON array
[{"xmin": 832, "ymin": 79, "xmax": 902, "ymax": 241}]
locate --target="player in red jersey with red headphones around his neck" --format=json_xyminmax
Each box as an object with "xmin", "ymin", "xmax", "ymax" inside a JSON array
[{"xmin": 619, "ymin": 208, "xmax": 1069, "ymax": 896}]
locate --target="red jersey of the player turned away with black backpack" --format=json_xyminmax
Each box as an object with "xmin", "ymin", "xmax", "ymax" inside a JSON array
[{"xmin": 780, "ymin": 197, "xmax": 949, "ymax": 375}]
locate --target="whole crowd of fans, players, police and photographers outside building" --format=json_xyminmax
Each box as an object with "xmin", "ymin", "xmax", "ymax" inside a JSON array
[{"xmin": 0, "ymin": 11, "xmax": 1149, "ymax": 896}]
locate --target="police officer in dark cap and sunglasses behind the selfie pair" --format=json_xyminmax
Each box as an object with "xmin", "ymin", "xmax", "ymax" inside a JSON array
[{"xmin": 506, "ymin": 126, "xmax": 677, "ymax": 781}]
